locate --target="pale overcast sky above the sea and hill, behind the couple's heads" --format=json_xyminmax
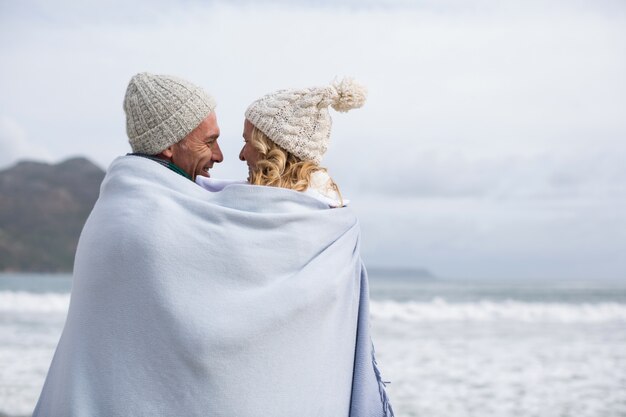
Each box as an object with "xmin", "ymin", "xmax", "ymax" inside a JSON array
[{"xmin": 0, "ymin": 0, "xmax": 626, "ymax": 279}]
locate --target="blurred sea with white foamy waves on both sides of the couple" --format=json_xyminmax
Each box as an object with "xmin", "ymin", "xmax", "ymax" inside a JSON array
[{"xmin": 0, "ymin": 273, "xmax": 626, "ymax": 417}]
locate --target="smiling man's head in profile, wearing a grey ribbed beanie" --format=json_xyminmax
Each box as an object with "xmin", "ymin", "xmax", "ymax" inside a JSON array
[{"xmin": 124, "ymin": 72, "xmax": 223, "ymax": 181}]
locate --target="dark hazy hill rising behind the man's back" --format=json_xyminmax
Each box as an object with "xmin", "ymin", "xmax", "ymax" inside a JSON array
[{"xmin": 0, "ymin": 158, "xmax": 104, "ymax": 272}]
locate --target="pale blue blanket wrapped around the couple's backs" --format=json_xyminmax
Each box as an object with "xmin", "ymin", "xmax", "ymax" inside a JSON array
[{"xmin": 34, "ymin": 156, "xmax": 392, "ymax": 417}]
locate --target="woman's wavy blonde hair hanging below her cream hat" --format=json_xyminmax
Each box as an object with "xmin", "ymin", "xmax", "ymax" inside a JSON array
[{"xmin": 249, "ymin": 126, "xmax": 343, "ymax": 204}]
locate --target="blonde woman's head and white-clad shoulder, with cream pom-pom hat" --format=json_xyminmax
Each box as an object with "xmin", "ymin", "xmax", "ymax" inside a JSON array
[{"xmin": 239, "ymin": 79, "xmax": 358, "ymax": 207}]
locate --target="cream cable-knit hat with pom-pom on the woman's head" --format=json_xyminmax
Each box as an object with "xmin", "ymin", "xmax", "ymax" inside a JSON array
[{"xmin": 245, "ymin": 78, "xmax": 367, "ymax": 164}]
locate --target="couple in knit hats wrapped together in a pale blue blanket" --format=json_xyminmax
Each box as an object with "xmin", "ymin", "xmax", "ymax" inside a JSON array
[{"xmin": 34, "ymin": 73, "xmax": 393, "ymax": 417}]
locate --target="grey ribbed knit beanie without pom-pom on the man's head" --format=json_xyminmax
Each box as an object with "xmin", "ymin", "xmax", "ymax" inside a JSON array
[{"xmin": 124, "ymin": 72, "xmax": 215, "ymax": 155}]
